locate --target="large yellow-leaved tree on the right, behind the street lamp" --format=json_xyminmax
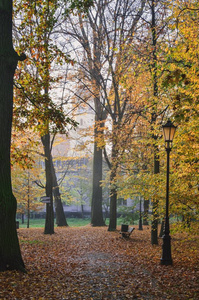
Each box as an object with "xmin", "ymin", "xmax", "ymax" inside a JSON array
[{"xmin": 115, "ymin": 1, "xmax": 198, "ymax": 234}]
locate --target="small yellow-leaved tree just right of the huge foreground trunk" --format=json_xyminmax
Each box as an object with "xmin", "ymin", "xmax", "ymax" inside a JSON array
[{"xmin": 11, "ymin": 127, "xmax": 42, "ymax": 227}]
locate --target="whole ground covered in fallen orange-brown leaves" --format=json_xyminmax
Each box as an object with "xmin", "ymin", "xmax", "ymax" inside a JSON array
[{"xmin": 0, "ymin": 226, "xmax": 199, "ymax": 300}]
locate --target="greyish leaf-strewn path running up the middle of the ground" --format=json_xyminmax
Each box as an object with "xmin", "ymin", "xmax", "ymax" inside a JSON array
[{"xmin": 68, "ymin": 229, "xmax": 161, "ymax": 300}]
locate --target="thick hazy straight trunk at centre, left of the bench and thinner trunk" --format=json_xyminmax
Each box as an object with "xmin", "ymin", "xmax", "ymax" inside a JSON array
[{"xmin": 91, "ymin": 123, "xmax": 105, "ymax": 226}]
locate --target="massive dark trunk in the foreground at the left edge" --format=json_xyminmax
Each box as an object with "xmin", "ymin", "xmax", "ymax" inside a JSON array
[{"xmin": 0, "ymin": 0, "xmax": 25, "ymax": 272}]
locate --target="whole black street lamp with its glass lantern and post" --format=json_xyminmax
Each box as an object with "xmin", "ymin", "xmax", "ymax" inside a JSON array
[{"xmin": 161, "ymin": 120, "xmax": 176, "ymax": 265}]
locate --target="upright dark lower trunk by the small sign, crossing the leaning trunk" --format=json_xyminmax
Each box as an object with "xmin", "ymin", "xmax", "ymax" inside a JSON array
[{"xmin": 41, "ymin": 133, "xmax": 54, "ymax": 234}]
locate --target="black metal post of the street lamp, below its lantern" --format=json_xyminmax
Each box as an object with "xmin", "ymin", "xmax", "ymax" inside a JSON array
[{"xmin": 161, "ymin": 145, "xmax": 172, "ymax": 265}]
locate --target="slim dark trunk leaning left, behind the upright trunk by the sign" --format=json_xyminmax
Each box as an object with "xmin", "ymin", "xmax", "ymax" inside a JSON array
[{"xmin": 50, "ymin": 155, "xmax": 68, "ymax": 227}]
